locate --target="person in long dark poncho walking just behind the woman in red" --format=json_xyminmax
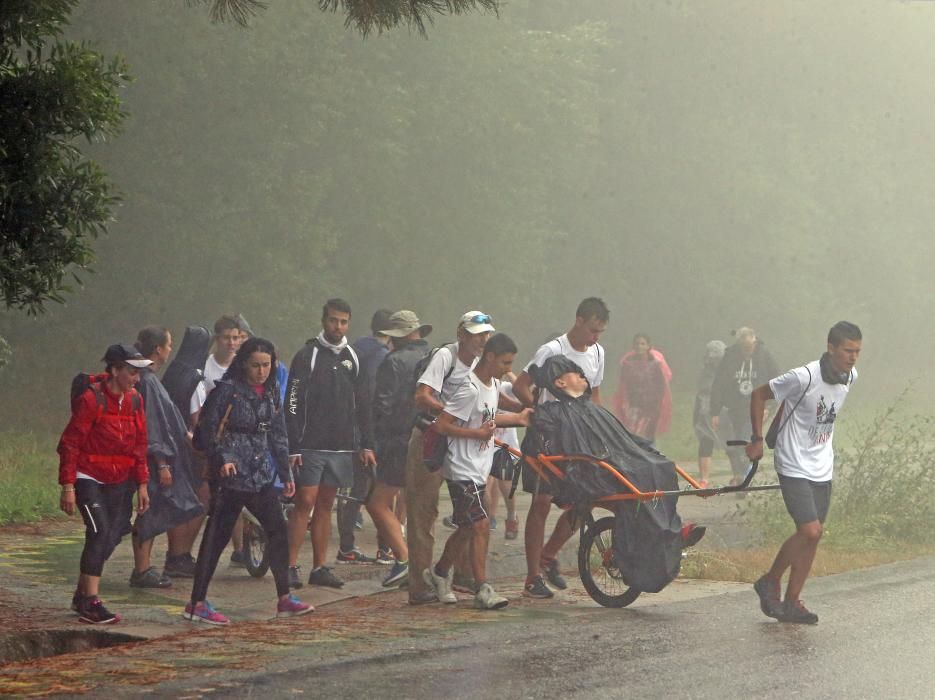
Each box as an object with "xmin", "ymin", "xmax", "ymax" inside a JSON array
[{"xmin": 130, "ymin": 326, "xmax": 204, "ymax": 588}]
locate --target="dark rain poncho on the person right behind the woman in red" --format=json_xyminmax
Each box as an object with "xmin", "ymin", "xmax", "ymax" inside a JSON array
[{"xmin": 136, "ymin": 369, "xmax": 204, "ymax": 542}]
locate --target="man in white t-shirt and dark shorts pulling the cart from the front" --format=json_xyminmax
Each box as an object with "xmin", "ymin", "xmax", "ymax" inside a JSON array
[{"xmin": 746, "ymin": 321, "xmax": 863, "ymax": 625}]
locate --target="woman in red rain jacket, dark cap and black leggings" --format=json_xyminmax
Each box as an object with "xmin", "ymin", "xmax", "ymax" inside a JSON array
[{"xmin": 58, "ymin": 344, "xmax": 152, "ymax": 625}]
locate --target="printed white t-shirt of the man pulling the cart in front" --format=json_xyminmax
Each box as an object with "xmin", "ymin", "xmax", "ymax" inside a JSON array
[{"xmin": 769, "ymin": 360, "xmax": 857, "ymax": 481}]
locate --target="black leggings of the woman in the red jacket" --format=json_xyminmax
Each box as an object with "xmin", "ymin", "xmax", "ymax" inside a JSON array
[{"xmin": 75, "ymin": 479, "xmax": 134, "ymax": 576}]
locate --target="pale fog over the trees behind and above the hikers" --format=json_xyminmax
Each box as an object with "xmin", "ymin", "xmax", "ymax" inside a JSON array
[{"xmin": 0, "ymin": 0, "xmax": 935, "ymax": 423}]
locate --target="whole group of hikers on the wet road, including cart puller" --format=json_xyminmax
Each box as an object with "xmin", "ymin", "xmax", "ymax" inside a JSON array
[{"xmin": 58, "ymin": 297, "xmax": 860, "ymax": 625}]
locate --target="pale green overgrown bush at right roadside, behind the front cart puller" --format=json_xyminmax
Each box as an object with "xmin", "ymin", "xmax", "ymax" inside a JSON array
[{"xmin": 743, "ymin": 392, "xmax": 935, "ymax": 549}]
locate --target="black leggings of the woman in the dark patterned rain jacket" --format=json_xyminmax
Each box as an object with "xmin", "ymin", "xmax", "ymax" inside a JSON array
[{"xmin": 192, "ymin": 484, "xmax": 289, "ymax": 604}]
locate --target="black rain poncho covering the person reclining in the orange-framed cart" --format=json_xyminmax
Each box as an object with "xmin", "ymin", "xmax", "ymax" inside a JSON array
[{"xmin": 523, "ymin": 356, "xmax": 682, "ymax": 593}]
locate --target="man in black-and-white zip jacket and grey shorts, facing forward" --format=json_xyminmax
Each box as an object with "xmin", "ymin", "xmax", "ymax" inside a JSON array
[{"xmin": 286, "ymin": 299, "xmax": 376, "ymax": 588}]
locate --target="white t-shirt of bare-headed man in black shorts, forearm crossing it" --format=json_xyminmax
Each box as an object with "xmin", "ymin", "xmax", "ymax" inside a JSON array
[{"xmin": 442, "ymin": 372, "xmax": 500, "ymax": 484}]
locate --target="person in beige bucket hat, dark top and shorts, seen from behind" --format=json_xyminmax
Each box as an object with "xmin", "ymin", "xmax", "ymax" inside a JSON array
[{"xmin": 367, "ymin": 311, "xmax": 432, "ymax": 587}]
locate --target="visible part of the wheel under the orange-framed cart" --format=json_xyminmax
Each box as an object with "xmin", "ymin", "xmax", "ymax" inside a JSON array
[{"xmin": 578, "ymin": 516, "xmax": 641, "ymax": 608}]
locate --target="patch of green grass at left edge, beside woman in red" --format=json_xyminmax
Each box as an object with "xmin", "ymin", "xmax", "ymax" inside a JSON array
[{"xmin": 0, "ymin": 432, "xmax": 61, "ymax": 525}]
